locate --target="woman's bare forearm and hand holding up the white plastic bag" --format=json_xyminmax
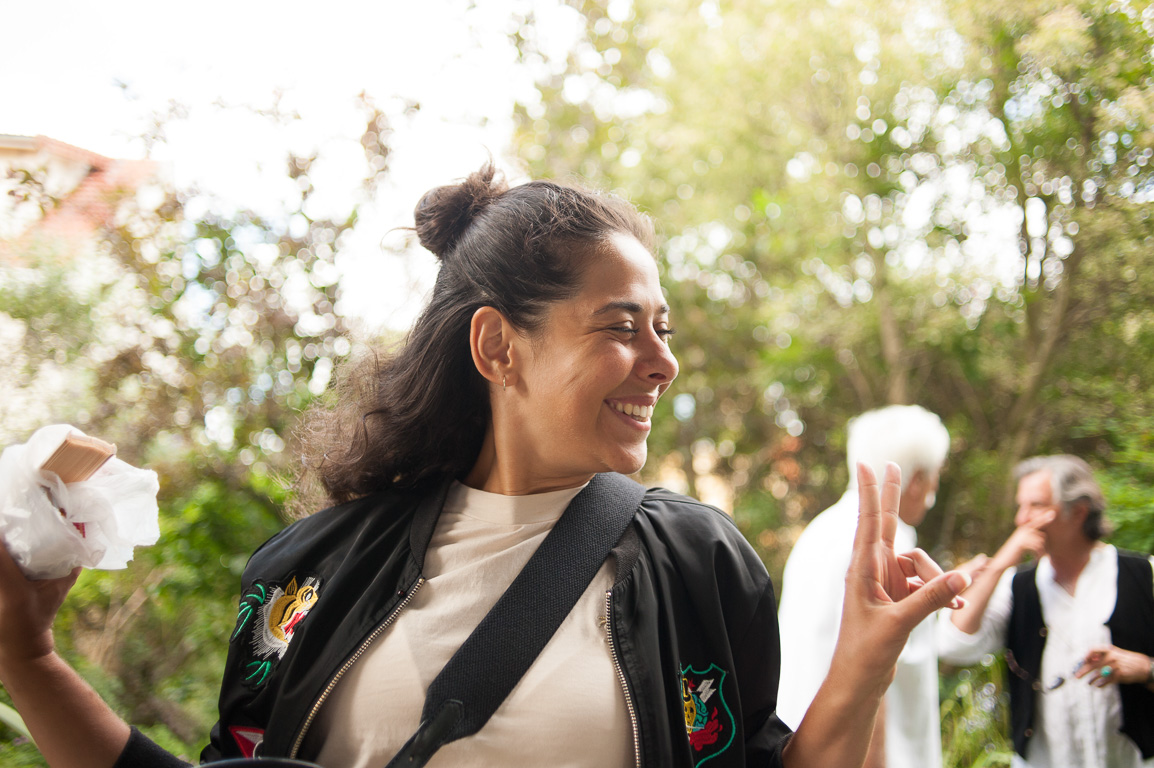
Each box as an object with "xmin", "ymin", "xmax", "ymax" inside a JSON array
[{"xmin": 0, "ymin": 545, "xmax": 129, "ymax": 768}]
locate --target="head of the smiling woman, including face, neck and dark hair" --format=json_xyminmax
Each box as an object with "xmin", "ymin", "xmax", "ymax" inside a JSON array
[{"xmin": 293, "ymin": 166, "xmax": 676, "ymax": 502}]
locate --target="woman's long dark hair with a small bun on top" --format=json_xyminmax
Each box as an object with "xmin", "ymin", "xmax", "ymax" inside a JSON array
[{"xmin": 298, "ymin": 164, "xmax": 653, "ymax": 509}]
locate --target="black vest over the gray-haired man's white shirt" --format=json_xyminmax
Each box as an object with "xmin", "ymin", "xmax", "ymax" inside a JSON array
[{"xmin": 1006, "ymin": 551, "xmax": 1154, "ymax": 760}]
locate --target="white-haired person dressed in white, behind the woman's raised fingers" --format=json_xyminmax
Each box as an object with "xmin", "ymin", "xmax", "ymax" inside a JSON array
[{"xmin": 778, "ymin": 406, "xmax": 950, "ymax": 768}]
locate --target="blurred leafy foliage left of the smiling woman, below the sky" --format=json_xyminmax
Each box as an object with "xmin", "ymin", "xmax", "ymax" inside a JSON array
[{"xmin": 0, "ymin": 100, "xmax": 408, "ymax": 765}]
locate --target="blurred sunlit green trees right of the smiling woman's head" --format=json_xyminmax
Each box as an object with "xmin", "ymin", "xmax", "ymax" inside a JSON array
[{"xmin": 518, "ymin": 0, "xmax": 1154, "ymax": 566}]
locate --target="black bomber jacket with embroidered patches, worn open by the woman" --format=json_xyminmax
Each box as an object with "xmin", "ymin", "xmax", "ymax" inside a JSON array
[{"xmin": 115, "ymin": 475, "xmax": 790, "ymax": 768}]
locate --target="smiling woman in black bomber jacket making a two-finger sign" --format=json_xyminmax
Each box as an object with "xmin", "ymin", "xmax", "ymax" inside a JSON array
[{"xmin": 0, "ymin": 166, "xmax": 964, "ymax": 768}]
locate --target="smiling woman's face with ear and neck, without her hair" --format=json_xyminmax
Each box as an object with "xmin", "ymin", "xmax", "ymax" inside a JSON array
[{"xmin": 466, "ymin": 233, "xmax": 677, "ymax": 495}]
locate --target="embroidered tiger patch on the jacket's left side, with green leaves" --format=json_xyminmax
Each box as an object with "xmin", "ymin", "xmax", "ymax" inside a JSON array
[{"xmin": 231, "ymin": 567, "xmax": 321, "ymax": 687}]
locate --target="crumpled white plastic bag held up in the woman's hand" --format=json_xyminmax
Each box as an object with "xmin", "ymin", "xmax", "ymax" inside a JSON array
[{"xmin": 0, "ymin": 424, "xmax": 160, "ymax": 579}]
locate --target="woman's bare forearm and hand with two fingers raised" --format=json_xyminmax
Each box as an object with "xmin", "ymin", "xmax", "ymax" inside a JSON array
[{"xmin": 784, "ymin": 465, "xmax": 968, "ymax": 768}]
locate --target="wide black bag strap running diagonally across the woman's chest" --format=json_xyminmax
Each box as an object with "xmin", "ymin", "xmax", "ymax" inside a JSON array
[{"xmin": 385, "ymin": 474, "xmax": 645, "ymax": 768}]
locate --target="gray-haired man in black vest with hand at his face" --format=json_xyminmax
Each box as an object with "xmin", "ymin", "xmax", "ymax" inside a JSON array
[{"xmin": 938, "ymin": 455, "xmax": 1154, "ymax": 768}]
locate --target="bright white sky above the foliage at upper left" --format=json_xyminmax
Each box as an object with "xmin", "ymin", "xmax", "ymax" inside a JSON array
[{"xmin": 0, "ymin": 0, "xmax": 575, "ymax": 326}]
